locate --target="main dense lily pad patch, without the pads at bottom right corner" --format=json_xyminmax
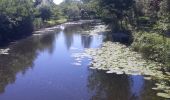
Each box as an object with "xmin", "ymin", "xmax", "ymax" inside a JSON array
[{"xmin": 86, "ymin": 42, "xmax": 164, "ymax": 78}]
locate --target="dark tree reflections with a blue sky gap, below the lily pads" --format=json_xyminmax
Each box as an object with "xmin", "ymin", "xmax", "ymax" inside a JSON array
[{"xmin": 87, "ymin": 70, "xmax": 163, "ymax": 100}]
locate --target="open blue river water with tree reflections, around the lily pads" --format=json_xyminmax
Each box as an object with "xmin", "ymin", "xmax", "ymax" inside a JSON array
[{"xmin": 0, "ymin": 24, "xmax": 162, "ymax": 100}]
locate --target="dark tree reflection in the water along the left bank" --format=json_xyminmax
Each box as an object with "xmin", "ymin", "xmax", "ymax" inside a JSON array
[{"xmin": 0, "ymin": 34, "xmax": 57, "ymax": 93}]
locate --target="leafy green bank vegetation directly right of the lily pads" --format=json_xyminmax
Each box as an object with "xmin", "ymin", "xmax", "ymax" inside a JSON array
[{"xmin": 132, "ymin": 31, "xmax": 170, "ymax": 70}]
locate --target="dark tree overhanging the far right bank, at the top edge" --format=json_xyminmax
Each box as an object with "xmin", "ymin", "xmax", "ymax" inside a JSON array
[{"xmin": 99, "ymin": 0, "xmax": 134, "ymax": 30}]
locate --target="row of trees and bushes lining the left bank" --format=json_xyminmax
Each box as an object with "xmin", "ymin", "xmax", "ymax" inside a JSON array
[{"xmin": 0, "ymin": 0, "xmax": 63, "ymax": 44}]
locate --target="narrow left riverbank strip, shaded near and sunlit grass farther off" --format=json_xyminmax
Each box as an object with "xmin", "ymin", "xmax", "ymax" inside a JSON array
[{"xmin": 0, "ymin": 18, "xmax": 67, "ymax": 47}]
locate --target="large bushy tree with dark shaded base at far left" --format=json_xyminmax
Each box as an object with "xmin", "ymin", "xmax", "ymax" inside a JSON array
[{"xmin": 0, "ymin": 0, "xmax": 34, "ymax": 41}]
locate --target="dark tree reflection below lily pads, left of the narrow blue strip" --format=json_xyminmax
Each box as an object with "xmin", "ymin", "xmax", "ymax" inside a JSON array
[{"xmin": 88, "ymin": 70, "xmax": 135, "ymax": 100}]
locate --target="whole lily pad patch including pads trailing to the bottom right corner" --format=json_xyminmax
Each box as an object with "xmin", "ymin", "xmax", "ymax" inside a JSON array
[{"xmin": 85, "ymin": 42, "xmax": 170, "ymax": 98}]
